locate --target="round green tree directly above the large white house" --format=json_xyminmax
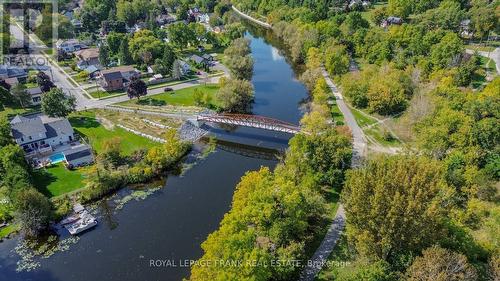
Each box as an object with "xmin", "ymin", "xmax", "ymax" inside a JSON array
[{"xmin": 42, "ymin": 88, "xmax": 76, "ymax": 117}]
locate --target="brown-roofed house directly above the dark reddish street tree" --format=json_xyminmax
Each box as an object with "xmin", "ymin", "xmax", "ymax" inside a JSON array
[{"xmin": 98, "ymin": 65, "xmax": 140, "ymax": 91}]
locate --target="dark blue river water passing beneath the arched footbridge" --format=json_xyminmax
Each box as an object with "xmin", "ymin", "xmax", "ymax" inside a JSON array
[{"xmin": 0, "ymin": 28, "xmax": 308, "ymax": 281}]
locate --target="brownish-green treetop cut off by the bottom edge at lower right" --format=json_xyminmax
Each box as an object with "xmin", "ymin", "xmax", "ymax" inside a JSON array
[{"xmin": 406, "ymin": 246, "xmax": 477, "ymax": 281}]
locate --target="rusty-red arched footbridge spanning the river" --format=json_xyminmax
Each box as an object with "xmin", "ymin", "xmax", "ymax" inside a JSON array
[{"xmin": 196, "ymin": 113, "xmax": 300, "ymax": 134}]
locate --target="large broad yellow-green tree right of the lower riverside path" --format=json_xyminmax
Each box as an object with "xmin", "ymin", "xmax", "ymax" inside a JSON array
[{"xmin": 342, "ymin": 156, "xmax": 450, "ymax": 262}]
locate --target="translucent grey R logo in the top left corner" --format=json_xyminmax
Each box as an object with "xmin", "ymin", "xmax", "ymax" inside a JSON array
[{"xmin": 0, "ymin": 0, "xmax": 59, "ymax": 67}]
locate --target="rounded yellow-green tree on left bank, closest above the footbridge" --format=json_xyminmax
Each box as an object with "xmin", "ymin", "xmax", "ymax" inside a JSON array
[{"xmin": 216, "ymin": 79, "xmax": 253, "ymax": 112}]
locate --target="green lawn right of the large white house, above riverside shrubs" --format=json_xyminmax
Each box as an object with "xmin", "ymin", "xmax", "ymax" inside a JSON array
[{"xmin": 69, "ymin": 111, "xmax": 157, "ymax": 155}]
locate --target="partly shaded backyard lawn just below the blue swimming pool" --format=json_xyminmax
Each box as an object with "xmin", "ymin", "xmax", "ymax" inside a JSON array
[{"xmin": 34, "ymin": 163, "xmax": 84, "ymax": 197}]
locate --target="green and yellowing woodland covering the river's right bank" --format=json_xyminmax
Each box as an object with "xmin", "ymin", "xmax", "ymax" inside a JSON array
[{"xmin": 191, "ymin": 0, "xmax": 500, "ymax": 280}]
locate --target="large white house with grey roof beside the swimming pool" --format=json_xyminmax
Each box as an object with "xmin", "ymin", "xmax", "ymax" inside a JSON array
[{"xmin": 10, "ymin": 115, "xmax": 75, "ymax": 153}]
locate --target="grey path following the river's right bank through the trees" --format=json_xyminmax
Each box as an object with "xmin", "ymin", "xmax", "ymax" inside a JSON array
[{"xmin": 299, "ymin": 68, "xmax": 367, "ymax": 281}]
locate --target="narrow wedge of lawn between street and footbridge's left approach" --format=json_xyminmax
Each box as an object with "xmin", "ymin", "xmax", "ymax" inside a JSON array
[{"xmin": 119, "ymin": 84, "xmax": 219, "ymax": 106}]
